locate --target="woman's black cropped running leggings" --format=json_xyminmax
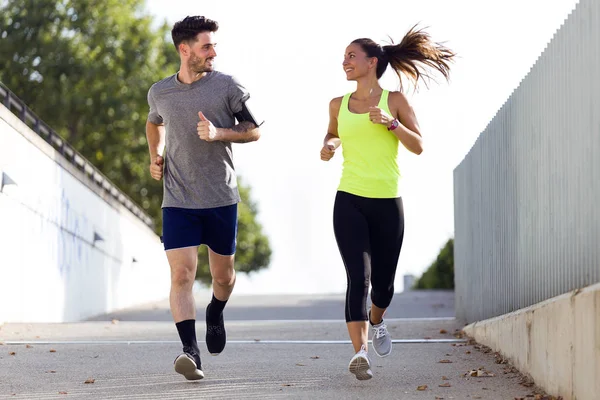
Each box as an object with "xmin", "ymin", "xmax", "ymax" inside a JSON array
[{"xmin": 333, "ymin": 191, "xmax": 404, "ymax": 322}]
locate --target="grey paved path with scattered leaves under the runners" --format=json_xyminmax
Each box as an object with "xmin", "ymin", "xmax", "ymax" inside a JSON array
[{"xmin": 0, "ymin": 292, "xmax": 531, "ymax": 400}]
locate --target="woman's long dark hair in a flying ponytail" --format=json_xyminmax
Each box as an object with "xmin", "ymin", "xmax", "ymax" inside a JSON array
[{"xmin": 352, "ymin": 25, "xmax": 456, "ymax": 89}]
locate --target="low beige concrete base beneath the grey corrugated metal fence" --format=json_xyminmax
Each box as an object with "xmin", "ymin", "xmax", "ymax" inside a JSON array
[{"xmin": 464, "ymin": 284, "xmax": 600, "ymax": 400}]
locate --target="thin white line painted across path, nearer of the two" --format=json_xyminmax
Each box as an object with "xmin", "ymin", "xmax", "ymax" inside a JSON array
[{"xmin": 3, "ymin": 339, "xmax": 466, "ymax": 345}]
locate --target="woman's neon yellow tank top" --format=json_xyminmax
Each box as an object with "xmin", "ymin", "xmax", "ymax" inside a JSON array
[{"xmin": 338, "ymin": 90, "xmax": 400, "ymax": 198}]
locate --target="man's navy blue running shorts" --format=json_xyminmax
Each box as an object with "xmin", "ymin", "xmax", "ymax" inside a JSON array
[{"xmin": 162, "ymin": 204, "xmax": 237, "ymax": 256}]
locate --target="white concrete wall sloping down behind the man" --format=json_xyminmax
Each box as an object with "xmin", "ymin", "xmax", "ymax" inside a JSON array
[{"xmin": 0, "ymin": 101, "xmax": 170, "ymax": 323}]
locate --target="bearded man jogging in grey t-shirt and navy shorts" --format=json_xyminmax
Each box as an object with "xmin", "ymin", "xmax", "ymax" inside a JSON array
[{"xmin": 146, "ymin": 16, "xmax": 260, "ymax": 380}]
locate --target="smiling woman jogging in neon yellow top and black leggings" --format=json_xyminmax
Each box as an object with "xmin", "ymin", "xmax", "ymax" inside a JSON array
[{"xmin": 321, "ymin": 27, "xmax": 454, "ymax": 380}]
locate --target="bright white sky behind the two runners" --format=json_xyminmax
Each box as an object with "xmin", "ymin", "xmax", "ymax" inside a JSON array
[{"xmin": 147, "ymin": 0, "xmax": 577, "ymax": 293}]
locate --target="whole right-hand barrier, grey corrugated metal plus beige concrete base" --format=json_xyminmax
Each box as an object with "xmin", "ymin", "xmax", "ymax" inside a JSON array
[{"xmin": 454, "ymin": 0, "xmax": 600, "ymax": 400}]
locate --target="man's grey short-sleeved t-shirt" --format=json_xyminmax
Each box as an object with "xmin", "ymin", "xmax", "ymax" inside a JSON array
[{"xmin": 148, "ymin": 71, "xmax": 250, "ymax": 209}]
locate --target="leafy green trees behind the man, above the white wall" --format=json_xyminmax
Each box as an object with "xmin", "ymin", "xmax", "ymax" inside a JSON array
[{"xmin": 0, "ymin": 0, "xmax": 270, "ymax": 282}]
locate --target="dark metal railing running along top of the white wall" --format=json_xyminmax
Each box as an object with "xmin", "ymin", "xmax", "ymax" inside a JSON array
[{"xmin": 0, "ymin": 82, "xmax": 154, "ymax": 228}]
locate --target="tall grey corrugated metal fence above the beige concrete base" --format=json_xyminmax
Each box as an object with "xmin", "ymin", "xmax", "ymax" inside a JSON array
[{"xmin": 454, "ymin": 0, "xmax": 600, "ymax": 322}]
